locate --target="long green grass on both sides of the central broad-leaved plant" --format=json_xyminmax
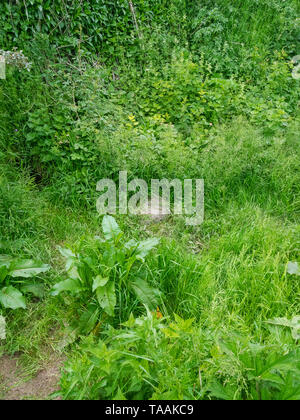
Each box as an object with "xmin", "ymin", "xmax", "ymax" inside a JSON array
[{"xmin": 0, "ymin": 115, "xmax": 300, "ymax": 398}]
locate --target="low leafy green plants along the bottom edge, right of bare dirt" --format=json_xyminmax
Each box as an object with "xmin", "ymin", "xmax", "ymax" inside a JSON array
[{"xmin": 60, "ymin": 312, "xmax": 300, "ymax": 400}]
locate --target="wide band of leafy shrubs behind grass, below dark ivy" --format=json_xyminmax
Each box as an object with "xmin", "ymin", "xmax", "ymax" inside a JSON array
[{"xmin": 0, "ymin": 48, "xmax": 299, "ymax": 206}]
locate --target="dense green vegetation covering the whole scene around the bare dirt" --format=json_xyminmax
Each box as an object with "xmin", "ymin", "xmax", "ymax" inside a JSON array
[{"xmin": 0, "ymin": 0, "xmax": 300, "ymax": 400}]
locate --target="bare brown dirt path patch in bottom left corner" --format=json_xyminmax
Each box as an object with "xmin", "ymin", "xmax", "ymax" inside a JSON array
[{"xmin": 0, "ymin": 356, "xmax": 63, "ymax": 400}]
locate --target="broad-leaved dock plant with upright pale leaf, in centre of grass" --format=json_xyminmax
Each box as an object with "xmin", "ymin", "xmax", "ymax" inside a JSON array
[{"xmin": 51, "ymin": 216, "xmax": 160, "ymax": 333}]
